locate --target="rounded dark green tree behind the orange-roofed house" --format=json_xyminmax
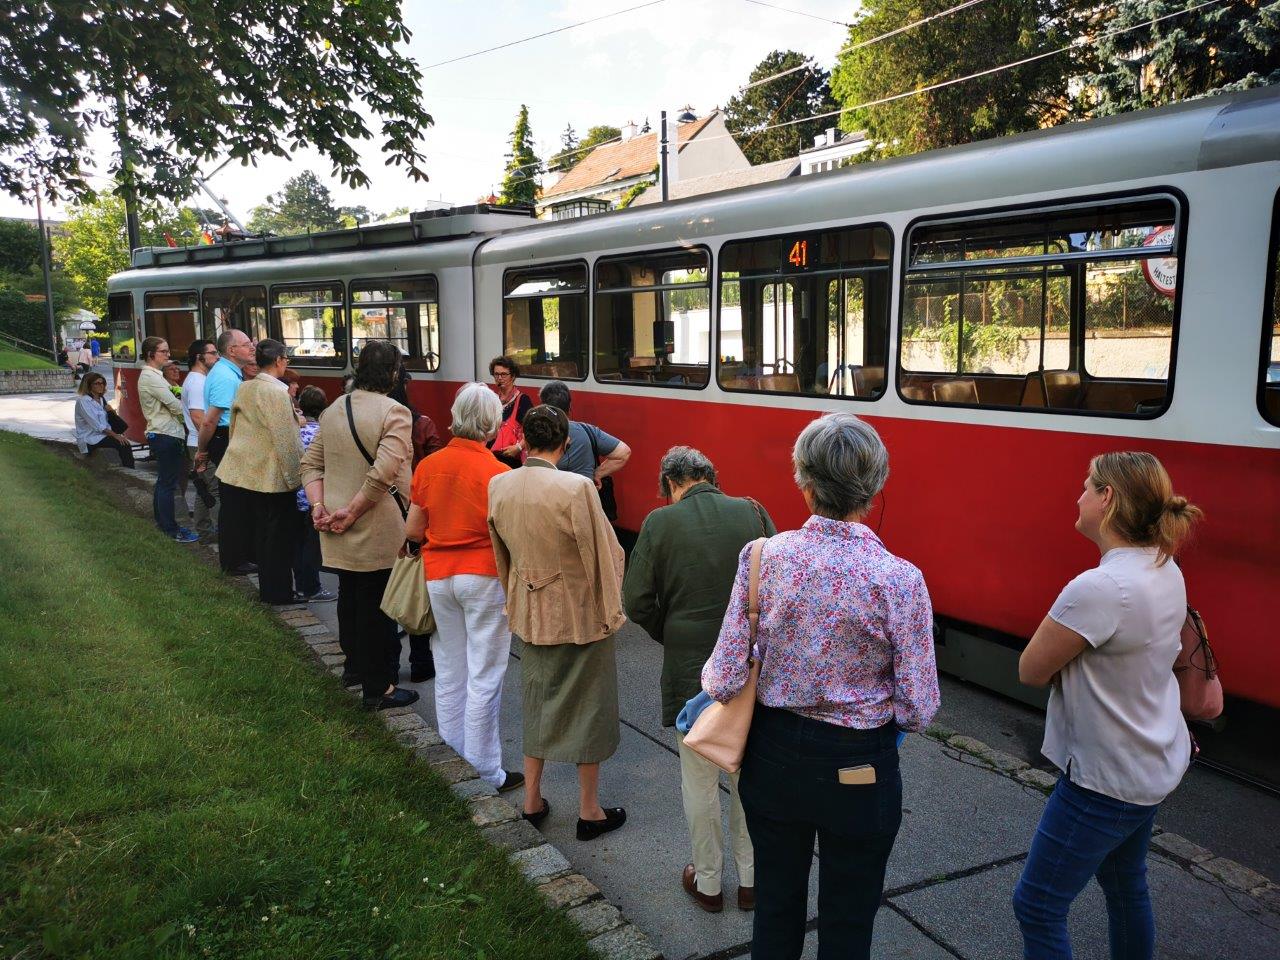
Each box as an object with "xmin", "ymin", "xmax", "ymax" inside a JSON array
[{"xmin": 724, "ymin": 50, "xmax": 836, "ymax": 164}]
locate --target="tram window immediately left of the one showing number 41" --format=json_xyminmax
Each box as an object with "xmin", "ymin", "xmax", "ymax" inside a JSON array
[{"xmin": 595, "ymin": 250, "xmax": 712, "ymax": 387}]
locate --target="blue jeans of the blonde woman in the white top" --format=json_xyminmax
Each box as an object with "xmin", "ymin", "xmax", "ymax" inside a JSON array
[{"xmin": 1014, "ymin": 777, "xmax": 1160, "ymax": 960}]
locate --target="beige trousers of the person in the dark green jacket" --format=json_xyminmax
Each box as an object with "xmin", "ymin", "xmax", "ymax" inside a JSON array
[{"xmin": 676, "ymin": 730, "xmax": 755, "ymax": 896}]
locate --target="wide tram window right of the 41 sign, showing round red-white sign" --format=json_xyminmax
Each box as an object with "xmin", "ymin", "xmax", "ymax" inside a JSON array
[{"xmin": 897, "ymin": 197, "xmax": 1178, "ymax": 416}]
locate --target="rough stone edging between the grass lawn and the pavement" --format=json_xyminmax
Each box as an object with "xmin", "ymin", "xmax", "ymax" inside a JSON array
[{"xmin": 275, "ymin": 604, "xmax": 662, "ymax": 960}]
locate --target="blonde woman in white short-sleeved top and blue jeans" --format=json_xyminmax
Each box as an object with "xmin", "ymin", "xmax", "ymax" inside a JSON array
[{"xmin": 1014, "ymin": 452, "xmax": 1202, "ymax": 960}]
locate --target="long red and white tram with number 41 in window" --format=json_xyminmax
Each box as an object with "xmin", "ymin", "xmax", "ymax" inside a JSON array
[{"xmin": 109, "ymin": 91, "xmax": 1280, "ymax": 707}]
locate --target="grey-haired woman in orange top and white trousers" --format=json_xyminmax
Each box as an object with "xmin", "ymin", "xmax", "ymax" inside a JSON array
[{"xmin": 404, "ymin": 383, "xmax": 525, "ymax": 790}]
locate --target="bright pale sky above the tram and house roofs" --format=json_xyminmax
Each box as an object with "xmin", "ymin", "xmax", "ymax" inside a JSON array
[{"xmin": 0, "ymin": 0, "xmax": 858, "ymax": 220}]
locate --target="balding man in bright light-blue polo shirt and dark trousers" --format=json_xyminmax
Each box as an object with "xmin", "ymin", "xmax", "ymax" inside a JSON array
[{"xmin": 196, "ymin": 330, "xmax": 253, "ymax": 573}]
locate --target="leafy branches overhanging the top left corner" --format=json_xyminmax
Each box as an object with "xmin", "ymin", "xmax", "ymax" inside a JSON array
[{"xmin": 0, "ymin": 0, "xmax": 431, "ymax": 198}]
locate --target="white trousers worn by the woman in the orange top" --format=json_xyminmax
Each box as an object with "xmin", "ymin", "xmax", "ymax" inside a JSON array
[{"xmin": 426, "ymin": 573, "xmax": 511, "ymax": 787}]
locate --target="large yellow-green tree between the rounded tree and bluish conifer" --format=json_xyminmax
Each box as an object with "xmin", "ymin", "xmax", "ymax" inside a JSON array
[{"xmin": 831, "ymin": 0, "xmax": 1097, "ymax": 160}]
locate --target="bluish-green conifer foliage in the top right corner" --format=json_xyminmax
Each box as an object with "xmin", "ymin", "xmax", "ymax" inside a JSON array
[{"xmin": 1085, "ymin": 0, "xmax": 1280, "ymax": 115}]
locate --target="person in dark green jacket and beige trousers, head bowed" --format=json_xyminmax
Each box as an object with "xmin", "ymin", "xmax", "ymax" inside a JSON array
[{"xmin": 622, "ymin": 447, "xmax": 777, "ymax": 913}]
